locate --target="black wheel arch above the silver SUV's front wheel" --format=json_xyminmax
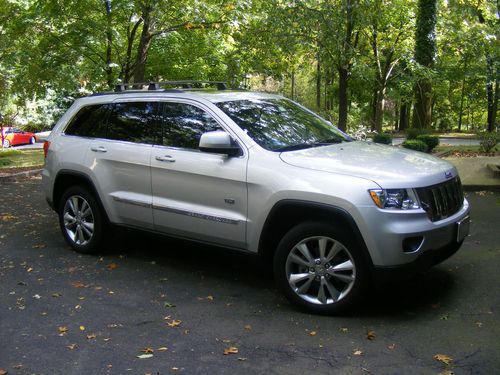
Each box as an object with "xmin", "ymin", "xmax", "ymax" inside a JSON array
[{"xmin": 259, "ymin": 200, "xmax": 373, "ymax": 268}]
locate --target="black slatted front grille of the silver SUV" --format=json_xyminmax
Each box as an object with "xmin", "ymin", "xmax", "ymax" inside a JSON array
[{"xmin": 417, "ymin": 176, "xmax": 464, "ymax": 221}]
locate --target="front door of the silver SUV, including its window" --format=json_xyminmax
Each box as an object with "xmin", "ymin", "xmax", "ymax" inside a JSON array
[{"xmin": 151, "ymin": 101, "xmax": 248, "ymax": 248}]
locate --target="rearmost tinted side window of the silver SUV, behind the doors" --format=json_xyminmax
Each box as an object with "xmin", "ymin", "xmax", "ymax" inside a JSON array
[{"xmin": 65, "ymin": 104, "xmax": 110, "ymax": 138}]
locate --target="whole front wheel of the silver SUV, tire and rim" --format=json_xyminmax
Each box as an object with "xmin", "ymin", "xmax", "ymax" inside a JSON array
[{"xmin": 274, "ymin": 222, "xmax": 369, "ymax": 315}]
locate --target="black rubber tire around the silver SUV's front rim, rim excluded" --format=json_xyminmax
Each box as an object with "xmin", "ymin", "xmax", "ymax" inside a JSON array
[{"xmin": 273, "ymin": 222, "xmax": 369, "ymax": 315}]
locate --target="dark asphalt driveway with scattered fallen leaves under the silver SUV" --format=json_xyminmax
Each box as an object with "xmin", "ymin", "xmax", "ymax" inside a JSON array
[{"xmin": 0, "ymin": 179, "xmax": 500, "ymax": 375}]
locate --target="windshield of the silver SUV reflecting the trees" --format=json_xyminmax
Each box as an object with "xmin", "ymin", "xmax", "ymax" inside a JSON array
[{"xmin": 216, "ymin": 98, "xmax": 351, "ymax": 151}]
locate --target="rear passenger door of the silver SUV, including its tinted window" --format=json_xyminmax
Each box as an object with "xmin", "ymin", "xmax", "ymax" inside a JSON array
[{"xmin": 86, "ymin": 100, "xmax": 158, "ymax": 229}]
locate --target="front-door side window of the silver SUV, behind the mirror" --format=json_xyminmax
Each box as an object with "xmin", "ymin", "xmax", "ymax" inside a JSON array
[{"xmin": 162, "ymin": 103, "xmax": 222, "ymax": 150}]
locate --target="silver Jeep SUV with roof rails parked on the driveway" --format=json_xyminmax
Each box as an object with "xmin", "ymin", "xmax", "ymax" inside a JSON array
[{"xmin": 43, "ymin": 84, "xmax": 469, "ymax": 314}]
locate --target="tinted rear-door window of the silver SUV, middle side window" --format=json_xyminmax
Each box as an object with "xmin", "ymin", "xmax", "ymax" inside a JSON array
[{"xmin": 106, "ymin": 102, "xmax": 159, "ymax": 144}]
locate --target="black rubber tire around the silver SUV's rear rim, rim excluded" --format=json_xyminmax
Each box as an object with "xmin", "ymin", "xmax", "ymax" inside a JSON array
[{"xmin": 58, "ymin": 186, "xmax": 104, "ymax": 254}]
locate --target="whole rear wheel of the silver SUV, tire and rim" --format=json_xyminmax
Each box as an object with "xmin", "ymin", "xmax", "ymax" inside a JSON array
[{"xmin": 58, "ymin": 186, "xmax": 105, "ymax": 254}]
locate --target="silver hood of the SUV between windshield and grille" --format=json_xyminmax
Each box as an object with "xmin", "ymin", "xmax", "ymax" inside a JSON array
[{"xmin": 280, "ymin": 141, "xmax": 457, "ymax": 188}]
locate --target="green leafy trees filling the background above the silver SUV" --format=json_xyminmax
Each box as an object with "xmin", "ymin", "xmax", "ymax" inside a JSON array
[{"xmin": 0, "ymin": 0, "xmax": 500, "ymax": 132}]
